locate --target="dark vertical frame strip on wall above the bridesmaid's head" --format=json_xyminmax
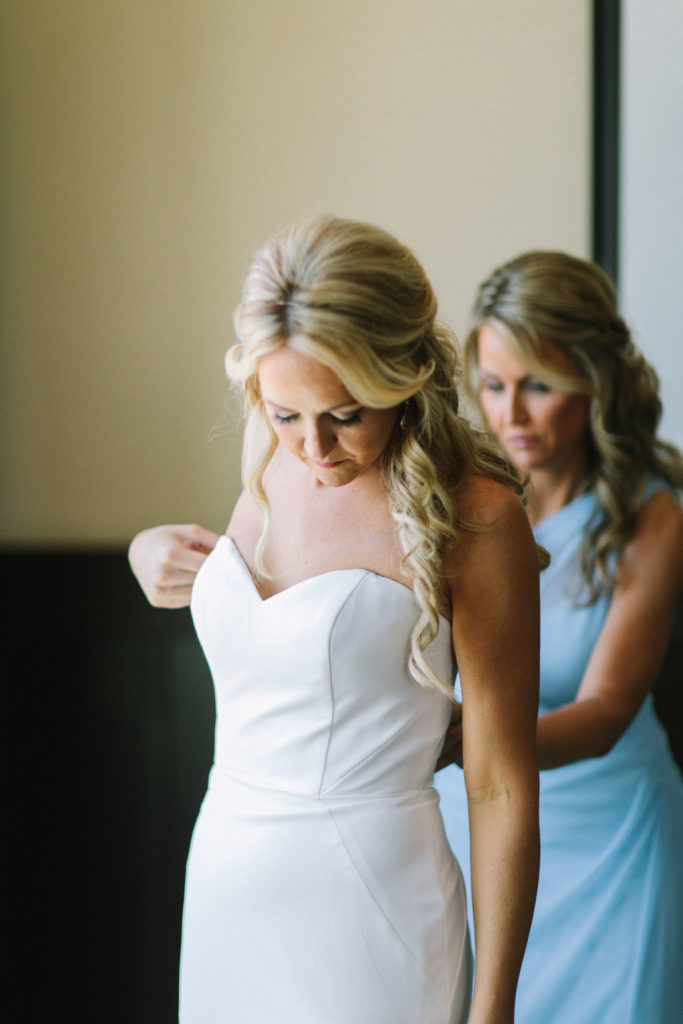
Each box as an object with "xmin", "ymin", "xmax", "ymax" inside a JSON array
[{"xmin": 592, "ymin": 0, "xmax": 622, "ymax": 282}]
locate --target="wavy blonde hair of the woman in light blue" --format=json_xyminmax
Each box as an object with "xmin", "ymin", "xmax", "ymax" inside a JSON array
[{"xmin": 464, "ymin": 251, "xmax": 683, "ymax": 603}]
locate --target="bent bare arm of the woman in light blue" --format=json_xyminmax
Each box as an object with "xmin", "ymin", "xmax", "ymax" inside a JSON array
[{"xmin": 538, "ymin": 492, "xmax": 683, "ymax": 768}]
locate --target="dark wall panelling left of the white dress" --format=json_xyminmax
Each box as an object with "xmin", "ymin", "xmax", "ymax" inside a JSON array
[{"xmin": 1, "ymin": 554, "xmax": 214, "ymax": 1024}]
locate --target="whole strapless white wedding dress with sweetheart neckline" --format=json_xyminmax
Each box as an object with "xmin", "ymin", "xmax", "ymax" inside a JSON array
[{"xmin": 180, "ymin": 537, "xmax": 471, "ymax": 1024}]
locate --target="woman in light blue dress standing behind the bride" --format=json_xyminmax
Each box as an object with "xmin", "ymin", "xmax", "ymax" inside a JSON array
[{"xmin": 437, "ymin": 252, "xmax": 683, "ymax": 1024}]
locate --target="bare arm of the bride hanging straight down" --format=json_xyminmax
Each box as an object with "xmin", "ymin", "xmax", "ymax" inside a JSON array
[{"xmin": 445, "ymin": 480, "xmax": 539, "ymax": 1024}]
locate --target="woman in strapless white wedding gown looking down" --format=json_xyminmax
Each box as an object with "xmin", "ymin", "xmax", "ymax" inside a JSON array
[{"xmin": 130, "ymin": 217, "xmax": 539, "ymax": 1024}]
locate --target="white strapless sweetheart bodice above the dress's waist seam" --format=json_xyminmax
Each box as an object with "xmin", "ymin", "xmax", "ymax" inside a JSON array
[{"xmin": 191, "ymin": 537, "xmax": 454, "ymax": 797}]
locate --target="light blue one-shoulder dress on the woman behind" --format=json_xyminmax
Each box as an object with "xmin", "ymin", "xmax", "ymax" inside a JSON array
[{"xmin": 436, "ymin": 481, "xmax": 683, "ymax": 1024}]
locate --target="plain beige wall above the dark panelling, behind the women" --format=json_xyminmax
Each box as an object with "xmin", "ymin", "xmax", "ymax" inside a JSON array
[{"xmin": 0, "ymin": 0, "xmax": 590, "ymax": 545}]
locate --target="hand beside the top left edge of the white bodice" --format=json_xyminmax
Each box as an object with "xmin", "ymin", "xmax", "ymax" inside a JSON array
[{"xmin": 128, "ymin": 524, "xmax": 220, "ymax": 608}]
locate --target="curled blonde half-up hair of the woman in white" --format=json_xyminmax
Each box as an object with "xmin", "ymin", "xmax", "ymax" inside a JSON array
[{"xmin": 225, "ymin": 216, "xmax": 522, "ymax": 696}]
